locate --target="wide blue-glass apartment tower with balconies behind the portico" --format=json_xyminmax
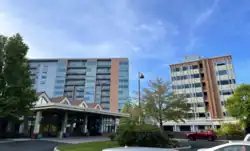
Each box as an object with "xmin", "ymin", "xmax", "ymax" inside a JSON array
[{"xmin": 29, "ymin": 58, "xmax": 129, "ymax": 112}]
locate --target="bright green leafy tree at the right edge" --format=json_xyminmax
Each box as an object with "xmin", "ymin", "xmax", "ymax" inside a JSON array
[{"xmin": 226, "ymin": 84, "xmax": 250, "ymax": 127}]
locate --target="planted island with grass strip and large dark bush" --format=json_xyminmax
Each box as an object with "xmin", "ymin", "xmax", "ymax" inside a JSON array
[{"xmin": 58, "ymin": 124, "xmax": 188, "ymax": 151}]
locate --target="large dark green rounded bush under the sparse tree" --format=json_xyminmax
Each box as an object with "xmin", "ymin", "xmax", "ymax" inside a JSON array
[{"xmin": 117, "ymin": 124, "xmax": 170, "ymax": 147}]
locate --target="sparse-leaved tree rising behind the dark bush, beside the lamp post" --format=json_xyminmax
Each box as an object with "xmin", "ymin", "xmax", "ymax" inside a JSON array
[{"xmin": 143, "ymin": 78, "xmax": 190, "ymax": 131}]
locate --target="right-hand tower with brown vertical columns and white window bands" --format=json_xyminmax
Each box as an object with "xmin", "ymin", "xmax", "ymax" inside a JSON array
[{"xmin": 170, "ymin": 55, "xmax": 236, "ymax": 119}]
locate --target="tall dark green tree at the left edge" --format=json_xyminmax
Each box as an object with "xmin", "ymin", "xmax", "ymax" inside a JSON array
[{"xmin": 0, "ymin": 34, "xmax": 37, "ymax": 118}]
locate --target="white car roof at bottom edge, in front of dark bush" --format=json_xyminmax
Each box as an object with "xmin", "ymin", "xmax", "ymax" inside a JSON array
[{"xmin": 102, "ymin": 147, "xmax": 178, "ymax": 151}]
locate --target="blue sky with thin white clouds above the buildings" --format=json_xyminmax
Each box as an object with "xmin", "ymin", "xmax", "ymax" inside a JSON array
[{"xmin": 0, "ymin": 0, "xmax": 250, "ymax": 90}]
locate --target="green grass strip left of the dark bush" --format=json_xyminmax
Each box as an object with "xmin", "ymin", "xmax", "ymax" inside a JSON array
[{"xmin": 58, "ymin": 141, "xmax": 119, "ymax": 151}]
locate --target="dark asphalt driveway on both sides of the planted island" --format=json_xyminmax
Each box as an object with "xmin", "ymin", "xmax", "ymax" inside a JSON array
[{"xmin": 0, "ymin": 140, "xmax": 228, "ymax": 151}]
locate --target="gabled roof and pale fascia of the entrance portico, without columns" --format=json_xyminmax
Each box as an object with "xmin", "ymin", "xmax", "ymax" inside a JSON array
[{"xmin": 32, "ymin": 92, "xmax": 130, "ymax": 118}]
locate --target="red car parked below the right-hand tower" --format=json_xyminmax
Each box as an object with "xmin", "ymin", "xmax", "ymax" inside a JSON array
[{"xmin": 186, "ymin": 130, "xmax": 217, "ymax": 141}]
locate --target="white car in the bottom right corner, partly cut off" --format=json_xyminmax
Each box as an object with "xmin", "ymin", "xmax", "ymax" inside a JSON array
[{"xmin": 197, "ymin": 141, "xmax": 250, "ymax": 151}]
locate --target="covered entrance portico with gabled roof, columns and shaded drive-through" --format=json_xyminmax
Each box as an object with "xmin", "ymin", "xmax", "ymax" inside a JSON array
[{"xmin": 28, "ymin": 93, "xmax": 129, "ymax": 138}]
